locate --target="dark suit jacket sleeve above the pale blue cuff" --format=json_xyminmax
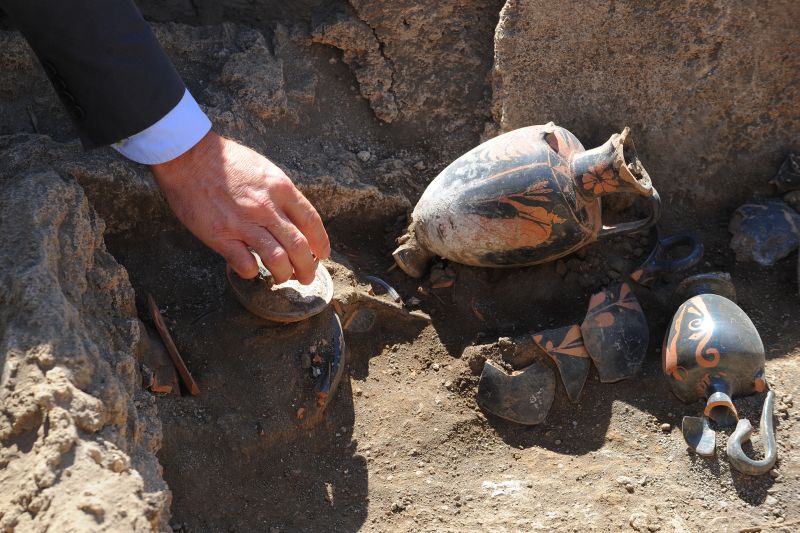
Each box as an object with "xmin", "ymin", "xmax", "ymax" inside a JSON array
[{"xmin": 0, "ymin": 0, "xmax": 185, "ymax": 148}]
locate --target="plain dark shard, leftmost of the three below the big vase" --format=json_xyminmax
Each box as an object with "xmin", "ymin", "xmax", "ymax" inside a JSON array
[{"xmin": 477, "ymin": 359, "xmax": 556, "ymax": 426}]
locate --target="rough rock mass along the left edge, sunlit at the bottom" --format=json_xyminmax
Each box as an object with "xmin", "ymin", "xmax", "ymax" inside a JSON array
[{"xmin": 0, "ymin": 171, "xmax": 170, "ymax": 531}]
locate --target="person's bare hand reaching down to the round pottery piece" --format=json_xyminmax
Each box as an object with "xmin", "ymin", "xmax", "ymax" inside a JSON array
[{"xmin": 150, "ymin": 131, "xmax": 330, "ymax": 284}]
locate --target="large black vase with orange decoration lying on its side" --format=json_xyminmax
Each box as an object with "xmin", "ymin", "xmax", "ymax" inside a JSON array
[{"xmin": 393, "ymin": 122, "xmax": 660, "ymax": 277}]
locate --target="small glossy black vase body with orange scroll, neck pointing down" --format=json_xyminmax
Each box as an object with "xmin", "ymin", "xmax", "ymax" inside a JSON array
[{"xmin": 662, "ymin": 294, "xmax": 766, "ymax": 425}]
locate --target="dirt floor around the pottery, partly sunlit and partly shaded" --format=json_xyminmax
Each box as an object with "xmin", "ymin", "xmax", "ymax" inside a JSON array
[{"xmin": 109, "ymin": 212, "xmax": 800, "ymax": 531}]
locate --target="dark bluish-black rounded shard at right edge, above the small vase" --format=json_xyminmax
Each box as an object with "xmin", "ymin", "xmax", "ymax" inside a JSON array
[{"xmin": 728, "ymin": 199, "xmax": 800, "ymax": 266}]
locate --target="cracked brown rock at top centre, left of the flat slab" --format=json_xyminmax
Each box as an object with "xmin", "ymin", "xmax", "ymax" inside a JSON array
[{"xmin": 313, "ymin": 0, "xmax": 501, "ymax": 133}]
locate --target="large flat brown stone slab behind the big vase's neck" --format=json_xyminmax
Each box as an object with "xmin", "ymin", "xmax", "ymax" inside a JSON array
[{"xmin": 493, "ymin": 0, "xmax": 800, "ymax": 224}]
